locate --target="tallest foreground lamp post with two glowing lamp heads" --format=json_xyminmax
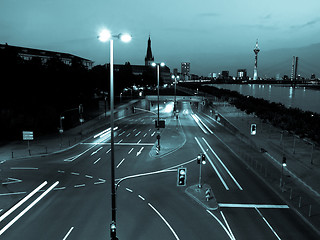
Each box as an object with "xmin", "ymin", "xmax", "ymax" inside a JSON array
[{"xmin": 98, "ymin": 29, "xmax": 131, "ymax": 240}]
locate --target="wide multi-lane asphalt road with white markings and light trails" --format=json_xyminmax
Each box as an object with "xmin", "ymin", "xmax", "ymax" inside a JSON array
[{"xmin": 0, "ymin": 102, "xmax": 319, "ymax": 240}]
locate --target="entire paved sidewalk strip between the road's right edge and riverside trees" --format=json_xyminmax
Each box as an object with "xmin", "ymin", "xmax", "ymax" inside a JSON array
[{"xmin": 210, "ymin": 105, "xmax": 320, "ymax": 235}]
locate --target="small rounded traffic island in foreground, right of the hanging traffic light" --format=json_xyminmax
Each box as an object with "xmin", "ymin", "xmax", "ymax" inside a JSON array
[{"xmin": 185, "ymin": 184, "xmax": 219, "ymax": 210}]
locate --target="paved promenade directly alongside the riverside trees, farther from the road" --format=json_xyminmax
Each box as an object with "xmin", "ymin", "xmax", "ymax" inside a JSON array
[{"xmin": 217, "ymin": 105, "xmax": 320, "ymax": 198}]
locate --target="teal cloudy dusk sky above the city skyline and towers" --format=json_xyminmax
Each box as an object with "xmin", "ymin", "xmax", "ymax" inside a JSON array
[{"xmin": 0, "ymin": 0, "xmax": 320, "ymax": 76}]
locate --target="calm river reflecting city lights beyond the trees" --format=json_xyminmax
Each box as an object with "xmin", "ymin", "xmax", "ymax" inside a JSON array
[{"xmin": 210, "ymin": 84, "xmax": 320, "ymax": 114}]
